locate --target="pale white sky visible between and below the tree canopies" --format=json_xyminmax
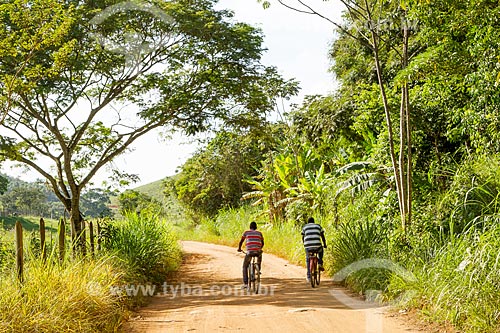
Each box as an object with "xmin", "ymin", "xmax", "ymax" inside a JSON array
[{"xmin": 3, "ymin": 0, "xmax": 343, "ymax": 187}]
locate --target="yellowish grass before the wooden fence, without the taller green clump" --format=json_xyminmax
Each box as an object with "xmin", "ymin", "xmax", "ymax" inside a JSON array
[{"xmin": 0, "ymin": 253, "xmax": 126, "ymax": 332}]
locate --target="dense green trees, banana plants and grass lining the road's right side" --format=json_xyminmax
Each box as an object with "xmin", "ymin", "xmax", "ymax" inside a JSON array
[{"xmin": 166, "ymin": 1, "xmax": 500, "ymax": 332}]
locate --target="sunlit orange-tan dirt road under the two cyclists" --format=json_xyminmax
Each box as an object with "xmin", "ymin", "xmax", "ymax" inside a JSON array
[{"xmin": 124, "ymin": 242, "xmax": 423, "ymax": 333}]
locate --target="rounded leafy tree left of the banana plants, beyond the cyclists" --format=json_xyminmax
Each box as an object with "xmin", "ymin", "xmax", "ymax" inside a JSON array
[{"xmin": 174, "ymin": 128, "xmax": 266, "ymax": 216}]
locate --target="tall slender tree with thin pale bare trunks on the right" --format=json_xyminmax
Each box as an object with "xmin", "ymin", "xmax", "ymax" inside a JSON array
[{"xmin": 257, "ymin": 0, "xmax": 422, "ymax": 230}]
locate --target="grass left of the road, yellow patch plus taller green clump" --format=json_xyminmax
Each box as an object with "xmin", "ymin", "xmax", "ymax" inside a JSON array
[{"xmin": 0, "ymin": 214, "xmax": 181, "ymax": 333}]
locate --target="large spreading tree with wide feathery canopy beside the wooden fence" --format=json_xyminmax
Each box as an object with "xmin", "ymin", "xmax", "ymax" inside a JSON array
[{"xmin": 0, "ymin": 0, "xmax": 295, "ymax": 248}]
